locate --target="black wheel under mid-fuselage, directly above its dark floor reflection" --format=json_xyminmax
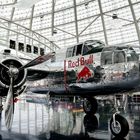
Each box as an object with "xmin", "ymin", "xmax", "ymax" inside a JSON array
[{"xmin": 83, "ymin": 98, "xmax": 98, "ymax": 114}]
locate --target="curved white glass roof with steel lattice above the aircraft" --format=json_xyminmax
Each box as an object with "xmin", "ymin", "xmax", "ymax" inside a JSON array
[{"xmin": 0, "ymin": 0, "xmax": 140, "ymax": 51}]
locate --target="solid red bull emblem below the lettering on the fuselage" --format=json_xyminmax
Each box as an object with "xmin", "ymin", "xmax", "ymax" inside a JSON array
[{"xmin": 77, "ymin": 66, "xmax": 93, "ymax": 81}]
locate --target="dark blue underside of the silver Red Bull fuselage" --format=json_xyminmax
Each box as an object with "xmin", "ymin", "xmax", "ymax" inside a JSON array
[{"xmin": 30, "ymin": 78, "xmax": 140, "ymax": 97}]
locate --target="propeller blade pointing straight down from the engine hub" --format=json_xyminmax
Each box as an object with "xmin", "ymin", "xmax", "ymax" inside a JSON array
[{"xmin": 5, "ymin": 77, "xmax": 14, "ymax": 129}]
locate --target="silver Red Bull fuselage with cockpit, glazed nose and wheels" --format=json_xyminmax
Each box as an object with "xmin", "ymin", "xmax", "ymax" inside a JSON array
[{"xmin": 30, "ymin": 40, "xmax": 140, "ymax": 137}]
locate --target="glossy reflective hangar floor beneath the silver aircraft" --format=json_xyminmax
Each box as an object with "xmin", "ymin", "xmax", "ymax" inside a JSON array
[{"xmin": 0, "ymin": 95, "xmax": 140, "ymax": 140}]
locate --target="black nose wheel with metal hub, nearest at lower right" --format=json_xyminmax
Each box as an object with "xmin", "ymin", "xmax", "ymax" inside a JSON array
[{"xmin": 110, "ymin": 114, "xmax": 129, "ymax": 138}]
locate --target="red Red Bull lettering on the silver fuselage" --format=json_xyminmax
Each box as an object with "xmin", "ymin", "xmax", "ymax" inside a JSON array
[{"xmin": 68, "ymin": 55, "xmax": 93, "ymax": 68}]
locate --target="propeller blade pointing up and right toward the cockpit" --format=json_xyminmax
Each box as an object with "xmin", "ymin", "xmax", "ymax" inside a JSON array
[{"xmin": 19, "ymin": 52, "xmax": 55, "ymax": 70}]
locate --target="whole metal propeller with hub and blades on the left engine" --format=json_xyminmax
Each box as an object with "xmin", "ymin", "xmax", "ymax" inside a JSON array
[{"xmin": 0, "ymin": 52, "xmax": 55, "ymax": 129}]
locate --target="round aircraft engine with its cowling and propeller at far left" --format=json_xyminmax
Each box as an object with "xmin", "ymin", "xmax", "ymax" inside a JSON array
[{"xmin": 0, "ymin": 48, "xmax": 54, "ymax": 130}]
